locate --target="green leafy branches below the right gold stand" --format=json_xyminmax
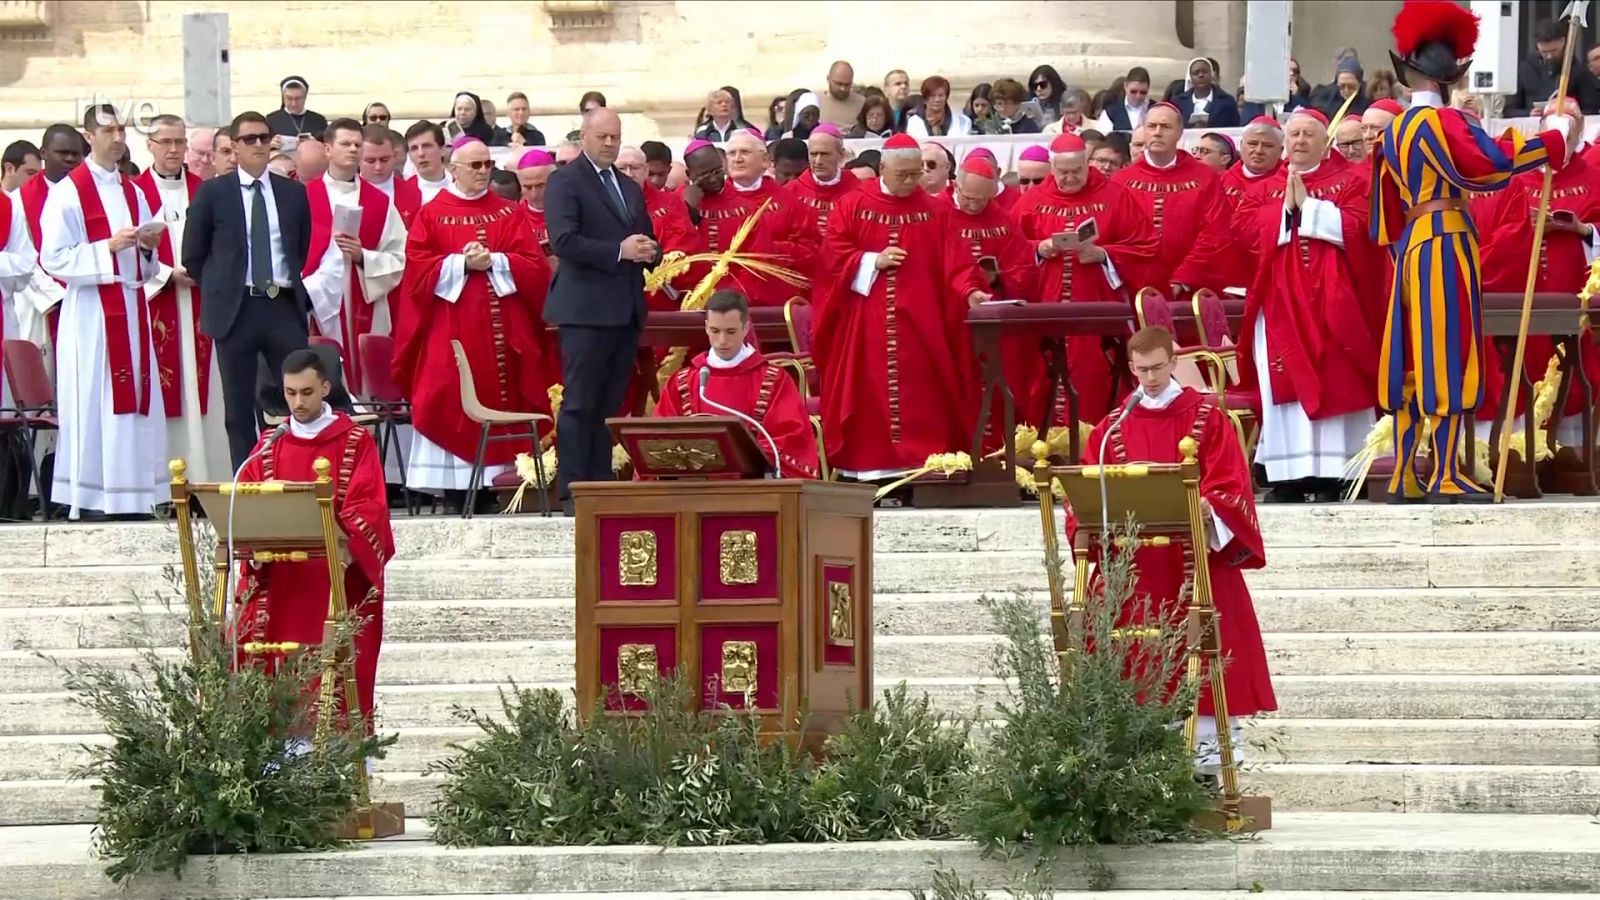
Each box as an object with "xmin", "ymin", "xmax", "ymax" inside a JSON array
[{"xmin": 952, "ymin": 532, "xmax": 1213, "ymax": 855}]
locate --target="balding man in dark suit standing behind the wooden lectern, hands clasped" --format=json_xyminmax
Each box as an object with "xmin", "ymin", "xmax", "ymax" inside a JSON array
[{"xmin": 544, "ymin": 107, "xmax": 661, "ymax": 514}]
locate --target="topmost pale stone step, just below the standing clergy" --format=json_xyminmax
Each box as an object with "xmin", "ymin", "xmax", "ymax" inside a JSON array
[{"xmin": 0, "ymin": 501, "xmax": 1600, "ymax": 567}]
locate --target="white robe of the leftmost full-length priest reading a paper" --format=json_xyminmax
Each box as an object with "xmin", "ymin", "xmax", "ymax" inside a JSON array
[{"xmin": 40, "ymin": 160, "xmax": 171, "ymax": 519}]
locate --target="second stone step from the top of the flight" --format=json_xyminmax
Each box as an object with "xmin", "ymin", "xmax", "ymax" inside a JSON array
[{"xmin": 9, "ymin": 544, "xmax": 1600, "ymax": 607}]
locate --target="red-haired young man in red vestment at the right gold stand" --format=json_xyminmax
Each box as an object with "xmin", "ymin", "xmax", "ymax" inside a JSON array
[{"xmin": 1067, "ymin": 328, "xmax": 1278, "ymax": 773}]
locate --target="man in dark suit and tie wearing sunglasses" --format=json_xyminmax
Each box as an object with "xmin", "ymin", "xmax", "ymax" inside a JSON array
[{"xmin": 182, "ymin": 112, "xmax": 310, "ymax": 468}]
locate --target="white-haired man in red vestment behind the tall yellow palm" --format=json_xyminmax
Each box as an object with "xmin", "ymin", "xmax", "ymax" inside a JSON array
[{"xmin": 683, "ymin": 131, "xmax": 816, "ymax": 306}]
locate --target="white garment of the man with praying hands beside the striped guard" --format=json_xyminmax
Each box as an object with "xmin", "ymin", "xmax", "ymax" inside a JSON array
[{"xmin": 1250, "ymin": 184, "xmax": 1376, "ymax": 482}]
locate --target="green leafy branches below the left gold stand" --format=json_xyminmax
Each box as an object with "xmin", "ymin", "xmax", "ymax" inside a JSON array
[{"xmin": 62, "ymin": 570, "xmax": 395, "ymax": 882}]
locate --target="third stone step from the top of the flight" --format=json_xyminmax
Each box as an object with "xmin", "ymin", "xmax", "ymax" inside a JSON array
[{"xmin": 12, "ymin": 588, "xmax": 1600, "ymax": 650}]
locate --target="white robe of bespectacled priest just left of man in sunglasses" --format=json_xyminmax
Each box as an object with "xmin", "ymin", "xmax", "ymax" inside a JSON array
[{"xmin": 144, "ymin": 164, "xmax": 234, "ymax": 482}]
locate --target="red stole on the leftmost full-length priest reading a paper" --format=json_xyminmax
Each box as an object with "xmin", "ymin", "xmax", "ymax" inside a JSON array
[{"xmin": 67, "ymin": 163, "xmax": 150, "ymax": 415}]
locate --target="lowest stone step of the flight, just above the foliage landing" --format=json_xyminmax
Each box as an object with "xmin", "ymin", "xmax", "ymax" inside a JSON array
[{"xmin": 0, "ymin": 764, "xmax": 1600, "ymax": 826}]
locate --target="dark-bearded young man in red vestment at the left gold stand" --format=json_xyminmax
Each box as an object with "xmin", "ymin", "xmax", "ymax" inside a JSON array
[{"xmin": 234, "ymin": 351, "xmax": 395, "ymax": 737}]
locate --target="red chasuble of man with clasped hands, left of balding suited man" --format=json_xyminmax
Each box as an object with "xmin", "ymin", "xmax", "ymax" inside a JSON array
[{"xmin": 394, "ymin": 191, "xmax": 560, "ymax": 466}]
